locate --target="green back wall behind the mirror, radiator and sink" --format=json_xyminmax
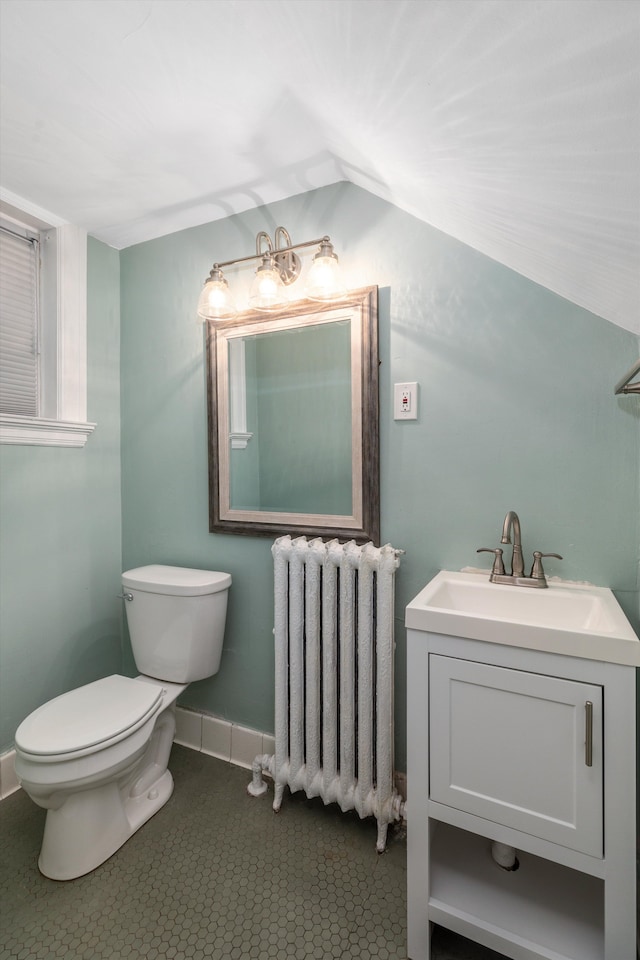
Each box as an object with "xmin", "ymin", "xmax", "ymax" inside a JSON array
[{"xmin": 121, "ymin": 183, "xmax": 640, "ymax": 769}]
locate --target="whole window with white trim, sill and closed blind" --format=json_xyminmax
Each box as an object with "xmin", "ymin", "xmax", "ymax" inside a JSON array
[{"xmin": 0, "ymin": 191, "xmax": 95, "ymax": 447}]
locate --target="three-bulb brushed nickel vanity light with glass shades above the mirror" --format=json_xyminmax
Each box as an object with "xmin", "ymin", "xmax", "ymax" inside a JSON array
[{"xmin": 198, "ymin": 227, "xmax": 346, "ymax": 320}]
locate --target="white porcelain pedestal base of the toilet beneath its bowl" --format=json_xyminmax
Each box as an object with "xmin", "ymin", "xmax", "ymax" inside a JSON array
[{"xmin": 38, "ymin": 769, "xmax": 173, "ymax": 880}]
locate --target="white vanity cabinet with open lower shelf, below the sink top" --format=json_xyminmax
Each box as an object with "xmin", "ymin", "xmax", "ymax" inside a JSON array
[{"xmin": 407, "ymin": 628, "xmax": 636, "ymax": 960}]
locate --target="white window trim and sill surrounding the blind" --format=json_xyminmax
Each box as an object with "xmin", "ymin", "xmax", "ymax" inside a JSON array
[{"xmin": 0, "ymin": 189, "xmax": 96, "ymax": 447}]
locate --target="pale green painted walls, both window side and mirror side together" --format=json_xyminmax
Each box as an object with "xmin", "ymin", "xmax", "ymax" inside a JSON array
[{"xmin": 0, "ymin": 184, "xmax": 640, "ymax": 769}]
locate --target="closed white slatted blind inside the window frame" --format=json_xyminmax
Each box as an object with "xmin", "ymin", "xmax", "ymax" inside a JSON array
[{"xmin": 0, "ymin": 226, "xmax": 39, "ymax": 417}]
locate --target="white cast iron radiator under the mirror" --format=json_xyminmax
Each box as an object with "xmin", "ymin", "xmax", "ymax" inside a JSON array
[{"xmin": 247, "ymin": 536, "xmax": 404, "ymax": 852}]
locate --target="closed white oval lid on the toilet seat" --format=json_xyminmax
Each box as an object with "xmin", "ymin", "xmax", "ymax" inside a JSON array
[{"xmin": 16, "ymin": 675, "xmax": 162, "ymax": 756}]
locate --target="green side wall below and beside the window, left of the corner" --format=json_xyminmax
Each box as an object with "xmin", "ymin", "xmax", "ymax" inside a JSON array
[{"xmin": 0, "ymin": 240, "xmax": 122, "ymax": 752}]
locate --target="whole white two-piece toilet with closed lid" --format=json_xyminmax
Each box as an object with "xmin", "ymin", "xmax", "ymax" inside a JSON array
[{"xmin": 15, "ymin": 564, "xmax": 231, "ymax": 880}]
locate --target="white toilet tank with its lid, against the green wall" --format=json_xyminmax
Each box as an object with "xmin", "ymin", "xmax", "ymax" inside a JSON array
[{"xmin": 122, "ymin": 564, "xmax": 231, "ymax": 683}]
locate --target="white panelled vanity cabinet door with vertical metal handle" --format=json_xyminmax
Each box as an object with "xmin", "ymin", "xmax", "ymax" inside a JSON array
[{"xmin": 429, "ymin": 655, "xmax": 603, "ymax": 857}]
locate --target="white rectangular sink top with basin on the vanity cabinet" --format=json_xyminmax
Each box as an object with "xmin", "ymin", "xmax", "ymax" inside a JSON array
[{"xmin": 406, "ymin": 570, "xmax": 640, "ymax": 666}]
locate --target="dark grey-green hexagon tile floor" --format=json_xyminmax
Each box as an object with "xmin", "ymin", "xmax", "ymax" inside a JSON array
[{"xmin": 0, "ymin": 746, "xmax": 508, "ymax": 960}]
